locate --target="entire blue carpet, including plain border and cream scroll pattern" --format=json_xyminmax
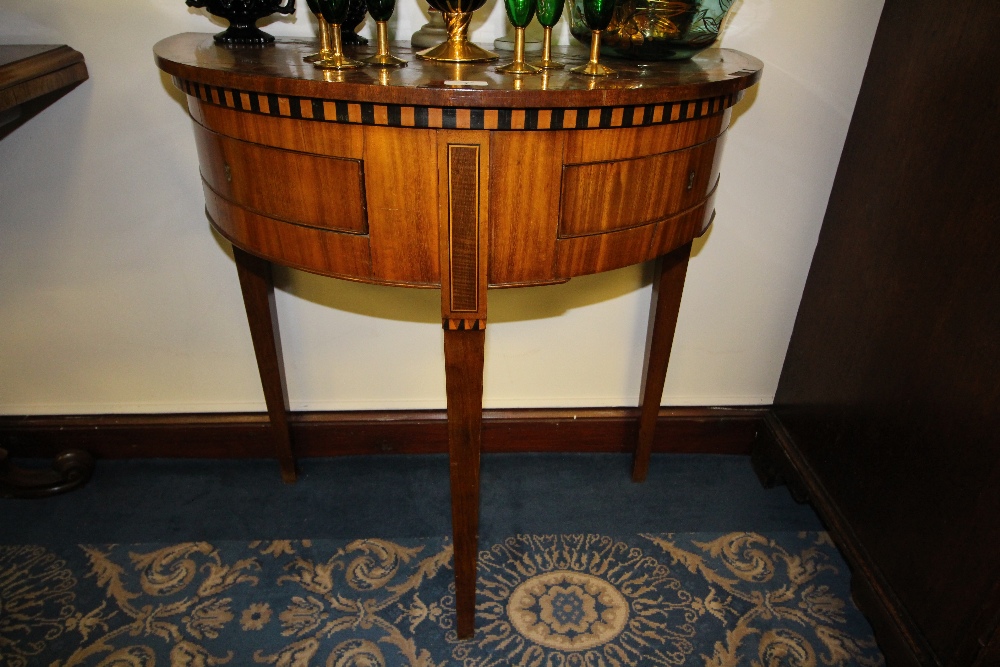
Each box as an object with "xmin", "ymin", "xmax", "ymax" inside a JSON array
[{"xmin": 0, "ymin": 454, "xmax": 882, "ymax": 667}]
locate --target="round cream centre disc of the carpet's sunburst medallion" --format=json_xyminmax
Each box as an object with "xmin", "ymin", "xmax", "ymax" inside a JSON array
[{"xmin": 507, "ymin": 571, "xmax": 628, "ymax": 651}]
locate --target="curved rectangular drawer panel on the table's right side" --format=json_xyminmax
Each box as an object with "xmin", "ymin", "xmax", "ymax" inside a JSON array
[{"xmin": 559, "ymin": 140, "xmax": 718, "ymax": 238}]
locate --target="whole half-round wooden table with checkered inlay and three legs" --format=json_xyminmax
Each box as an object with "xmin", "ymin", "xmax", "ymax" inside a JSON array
[{"xmin": 154, "ymin": 34, "xmax": 762, "ymax": 637}]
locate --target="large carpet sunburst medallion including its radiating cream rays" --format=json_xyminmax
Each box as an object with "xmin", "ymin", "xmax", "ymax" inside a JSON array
[{"xmin": 452, "ymin": 535, "xmax": 705, "ymax": 667}]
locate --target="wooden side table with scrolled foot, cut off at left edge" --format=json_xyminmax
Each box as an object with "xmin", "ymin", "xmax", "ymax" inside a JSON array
[{"xmin": 0, "ymin": 44, "xmax": 94, "ymax": 498}]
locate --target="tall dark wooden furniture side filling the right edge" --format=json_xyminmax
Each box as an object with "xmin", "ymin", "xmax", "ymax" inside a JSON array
[{"xmin": 756, "ymin": 0, "xmax": 1000, "ymax": 667}]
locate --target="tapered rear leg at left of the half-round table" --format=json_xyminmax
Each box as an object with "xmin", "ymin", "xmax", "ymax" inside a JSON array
[{"xmin": 233, "ymin": 246, "xmax": 296, "ymax": 482}]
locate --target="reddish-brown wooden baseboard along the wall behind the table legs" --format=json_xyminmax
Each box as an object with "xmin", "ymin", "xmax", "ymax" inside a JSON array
[{"xmin": 0, "ymin": 407, "xmax": 768, "ymax": 459}]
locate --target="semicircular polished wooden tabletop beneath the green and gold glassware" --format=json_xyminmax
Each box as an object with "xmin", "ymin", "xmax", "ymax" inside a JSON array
[{"xmin": 154, "ymin": 33, "xmax": 763, "ymax": 109}]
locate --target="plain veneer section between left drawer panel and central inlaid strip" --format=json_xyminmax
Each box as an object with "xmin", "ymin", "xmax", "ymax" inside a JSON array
[{"xmin": 364, "ymin": 127, "xmax": 441, "ymax": 286}]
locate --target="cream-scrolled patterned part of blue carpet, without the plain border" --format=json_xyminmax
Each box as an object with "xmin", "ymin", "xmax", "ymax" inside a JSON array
[{"xmin": 0, "ymin": 532, "xmax": 883, "ymax": 667}]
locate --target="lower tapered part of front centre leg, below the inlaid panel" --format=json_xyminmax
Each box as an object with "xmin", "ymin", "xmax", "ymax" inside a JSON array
[{"xmin": 444, "ymin": 329, "xmax": 486, "ymax": 639}]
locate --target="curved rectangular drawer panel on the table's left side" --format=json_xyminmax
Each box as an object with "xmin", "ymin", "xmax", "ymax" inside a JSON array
[{"xmin": 195, "ymin": 124, "xmax": 368, "ymax": 234}]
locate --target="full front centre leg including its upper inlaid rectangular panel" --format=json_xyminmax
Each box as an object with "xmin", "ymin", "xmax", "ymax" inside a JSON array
[{"xmin": 438, "ymin": 131, "xmax": 489, "ymax": 639}]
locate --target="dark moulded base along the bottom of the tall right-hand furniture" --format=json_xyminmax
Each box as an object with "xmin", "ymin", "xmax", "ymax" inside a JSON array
[{"xmin": 751, "ymin": 410, "xmax": 939, "ymax": 667}]
